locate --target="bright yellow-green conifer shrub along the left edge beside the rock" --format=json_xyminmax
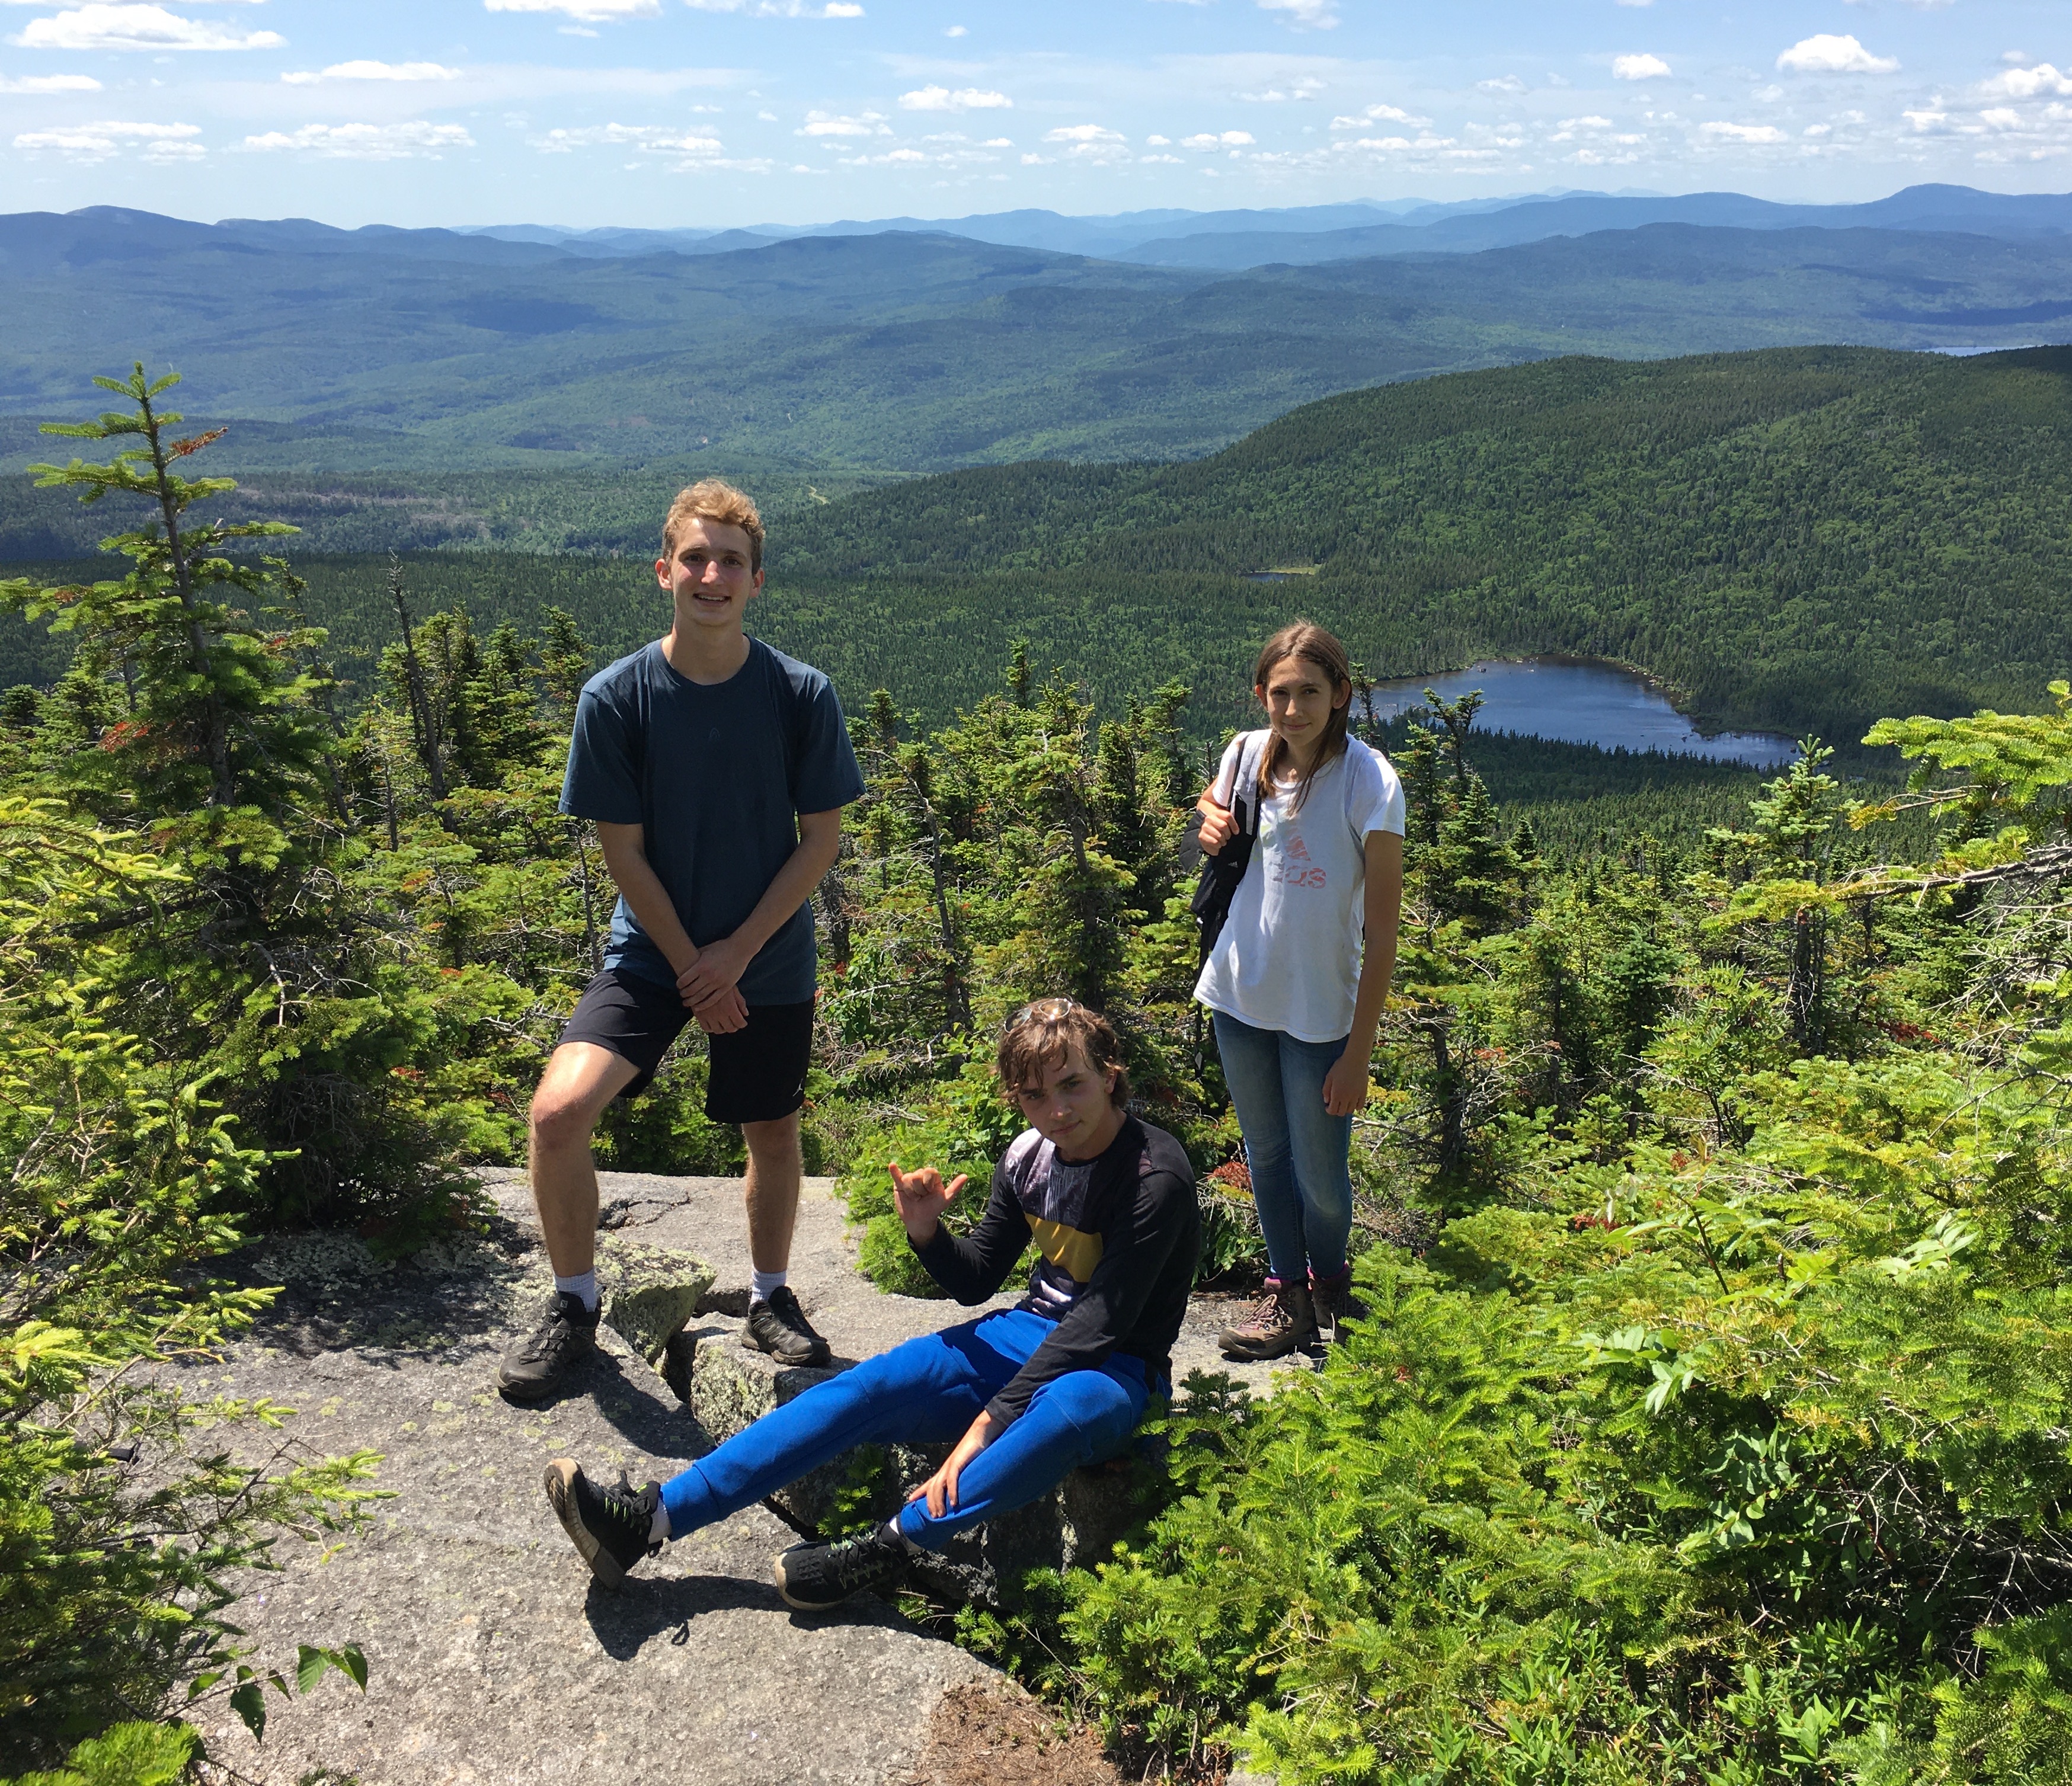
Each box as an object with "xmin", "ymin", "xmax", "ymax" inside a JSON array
[{"xmin": 0, "ymin": 800, "xmax": 377, "ymax": 1772}]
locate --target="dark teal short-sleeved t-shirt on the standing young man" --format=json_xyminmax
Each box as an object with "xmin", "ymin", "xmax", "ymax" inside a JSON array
[{"xmin": 561, "ymin": 638, "xmax": 864, "ymax": 1005}]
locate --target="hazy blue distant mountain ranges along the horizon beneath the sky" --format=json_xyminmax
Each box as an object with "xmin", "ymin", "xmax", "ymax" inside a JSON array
[{"xmin": 0, "ymin": 187, "xmax": 2072, "ymax": 482}]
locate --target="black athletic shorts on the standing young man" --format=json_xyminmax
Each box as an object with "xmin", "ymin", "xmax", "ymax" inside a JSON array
[{"xmin": 555, "ymin": 968, "xmax": 812, "ymax": 1123}]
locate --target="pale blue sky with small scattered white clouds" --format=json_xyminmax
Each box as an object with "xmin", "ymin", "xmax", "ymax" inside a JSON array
[{"xmin": 0, "ymin": 0, "xmax": 2072, "ymax": 228}]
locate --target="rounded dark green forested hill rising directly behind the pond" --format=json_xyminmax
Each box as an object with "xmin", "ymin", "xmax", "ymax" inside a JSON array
[{"xmin": 773, "ymin": 348, "xmax": 2072, "ymax": 735}]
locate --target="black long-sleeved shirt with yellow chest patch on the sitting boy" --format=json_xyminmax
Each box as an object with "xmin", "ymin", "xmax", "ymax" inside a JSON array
[{"xmin": 914, "ymin": 1117, "xmax": 1202, "ymax": 1427}]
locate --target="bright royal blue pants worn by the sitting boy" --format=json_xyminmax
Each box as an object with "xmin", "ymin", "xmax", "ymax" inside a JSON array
[{"xmin": 661, "ymin": 1310, "xmax": 1150, "ymax": 1550}]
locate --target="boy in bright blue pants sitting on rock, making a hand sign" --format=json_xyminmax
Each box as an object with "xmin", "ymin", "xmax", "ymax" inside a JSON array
[{"xmin": 547, "ymin": 998, "xmax": 1202, "ymax": 1612}]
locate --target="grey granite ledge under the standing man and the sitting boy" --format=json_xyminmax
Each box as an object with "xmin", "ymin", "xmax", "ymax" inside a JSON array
[{"xmin": 174, "ymin": 1171, "xmax": 1309, "ymax": 1786}]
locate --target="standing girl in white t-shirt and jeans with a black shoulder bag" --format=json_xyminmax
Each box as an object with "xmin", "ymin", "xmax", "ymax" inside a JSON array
[{"xmin": 1194, "ymin": 622, "xmax": 1405, "ymax": 1357}]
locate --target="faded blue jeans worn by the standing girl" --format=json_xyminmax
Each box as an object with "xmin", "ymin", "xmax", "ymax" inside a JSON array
[{"xmin": 1210, "ymin": 1011, "xmax": 1353, "ymax": 1285}]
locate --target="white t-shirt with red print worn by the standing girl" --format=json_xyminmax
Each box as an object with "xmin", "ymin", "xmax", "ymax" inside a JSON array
[{"xmin": 1194, "ymin": 731, "xmax": 1405, "ymax": 1042}]
